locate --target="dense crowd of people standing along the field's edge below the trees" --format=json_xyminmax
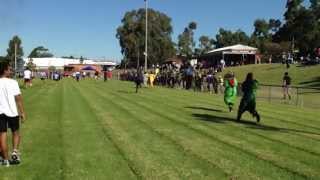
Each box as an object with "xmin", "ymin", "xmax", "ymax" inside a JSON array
[{"xmin": 120, "ymin": 64, "xmax": 223, "ymax": 94}]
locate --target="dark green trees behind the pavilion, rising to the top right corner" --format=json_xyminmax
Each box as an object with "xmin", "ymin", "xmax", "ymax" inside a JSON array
[{"xmin": 198, "ymin": 0, "xmax": 320, "ymax": 55}]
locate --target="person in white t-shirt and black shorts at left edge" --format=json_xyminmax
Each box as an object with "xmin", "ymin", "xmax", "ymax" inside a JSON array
[{"xmin": 0, "ymin": 61, "xmax": 26, "ymax": 166}]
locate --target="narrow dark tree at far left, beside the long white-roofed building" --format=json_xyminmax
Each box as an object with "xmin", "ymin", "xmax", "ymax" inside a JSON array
[{"xmin": 7, "ymin": 36, "xmax": 23, "ymax": 68}]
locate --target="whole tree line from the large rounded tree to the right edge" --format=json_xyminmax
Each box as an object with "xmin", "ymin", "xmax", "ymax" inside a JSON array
[{"xmin": 117, "ymin": 0, "xmax": 320, "ymax": 64}]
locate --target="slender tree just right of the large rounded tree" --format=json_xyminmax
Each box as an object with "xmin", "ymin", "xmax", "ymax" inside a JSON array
[{"xmin": 178, "ymin": 22, "xmax": 197, "ymax": 59}]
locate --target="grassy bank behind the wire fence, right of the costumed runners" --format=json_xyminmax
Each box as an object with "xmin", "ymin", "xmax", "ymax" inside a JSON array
[{"xmin": 219, "ymin": 64, "xmax": 320, "ymax": 109}]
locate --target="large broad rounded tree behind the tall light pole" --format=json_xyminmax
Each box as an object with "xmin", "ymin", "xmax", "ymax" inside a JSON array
[{"xmin": 116, "ymin": 9, "xmax": 175, "ymax": 66}]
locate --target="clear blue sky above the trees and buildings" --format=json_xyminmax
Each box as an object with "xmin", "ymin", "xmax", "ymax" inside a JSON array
[{"xmin": 0, "ymin": 0, "xmax": 286, "ymax": 61}]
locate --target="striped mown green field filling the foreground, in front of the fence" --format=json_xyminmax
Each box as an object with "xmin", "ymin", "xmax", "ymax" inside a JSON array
[{"xmin": 0, "ymin": 76, "xmax": 320, "ymax": 180}]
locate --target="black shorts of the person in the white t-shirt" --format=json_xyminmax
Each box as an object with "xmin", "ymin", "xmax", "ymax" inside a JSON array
[{"xmin": 0, "ymin": 114, "xmax": 20, "ymax": 132}]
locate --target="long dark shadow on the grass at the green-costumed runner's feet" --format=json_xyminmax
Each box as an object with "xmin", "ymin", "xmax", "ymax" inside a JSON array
[{"xmin": 192, "ymin": 114, "xmax": 320, "ymax": 135}]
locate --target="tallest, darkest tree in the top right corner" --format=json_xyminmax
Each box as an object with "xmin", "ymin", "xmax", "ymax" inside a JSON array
[{"xmin": 273, "ymin": 0, "xmax": 320, "ymax": 55}]
